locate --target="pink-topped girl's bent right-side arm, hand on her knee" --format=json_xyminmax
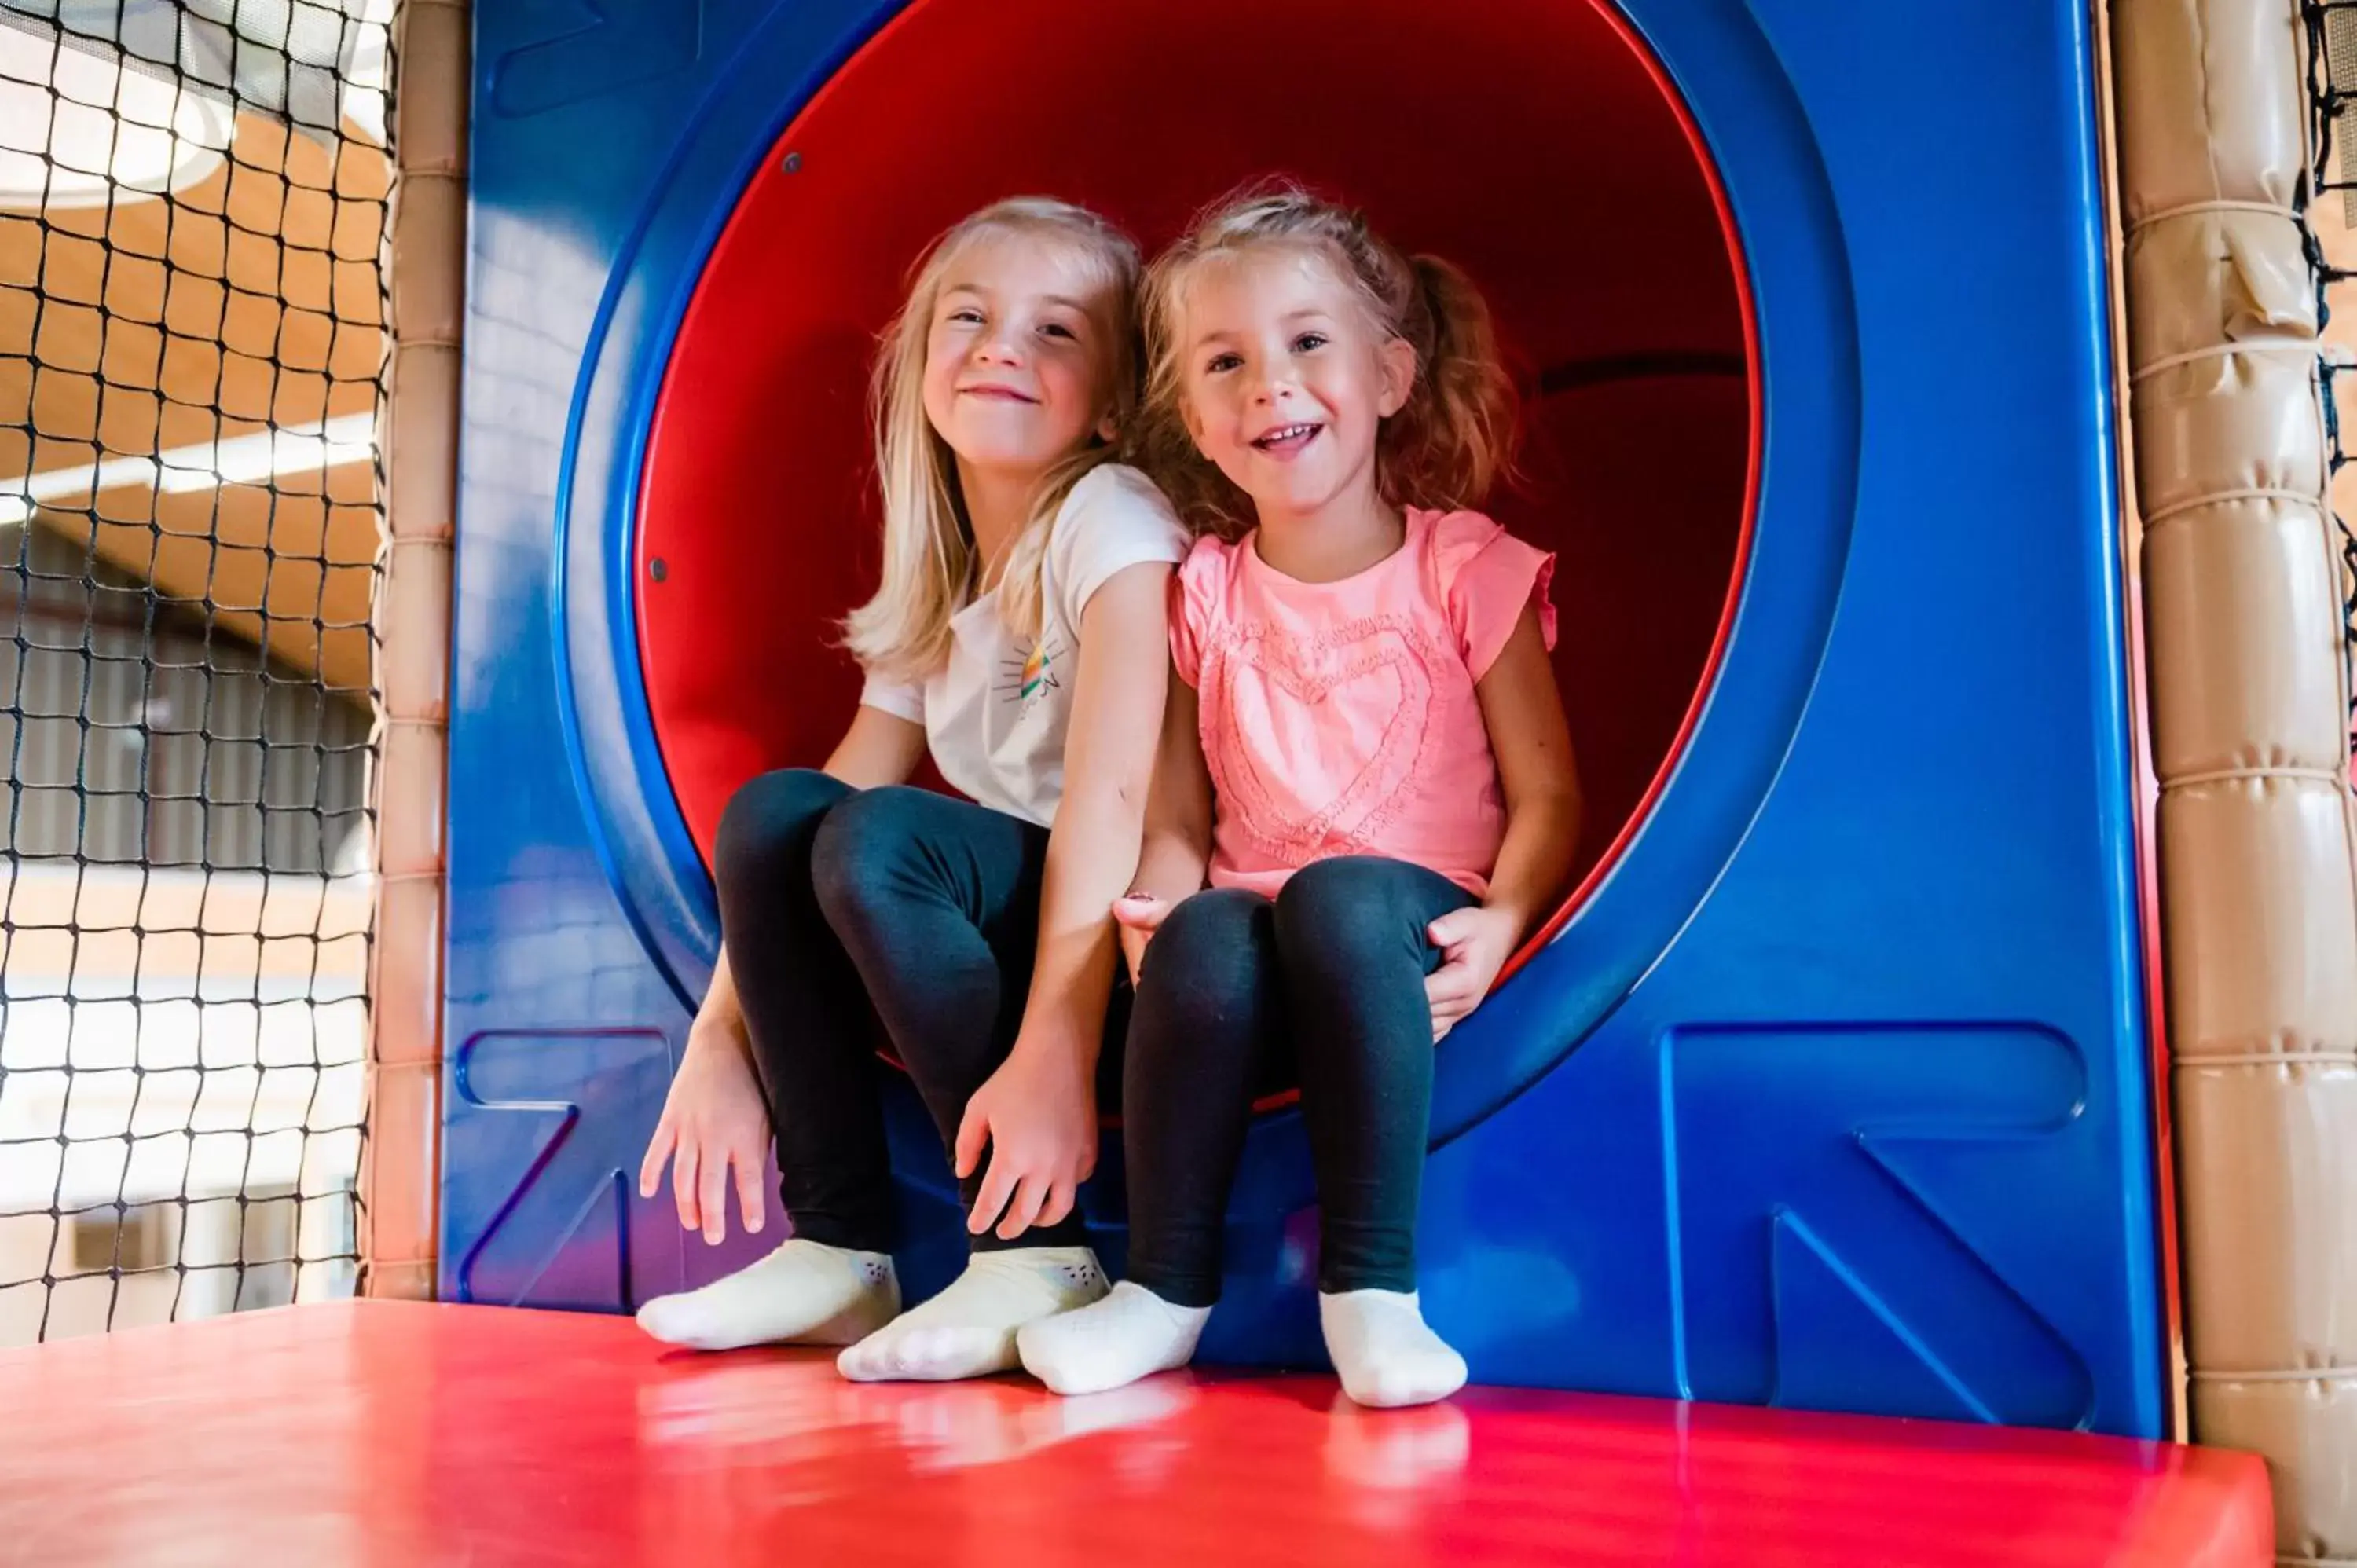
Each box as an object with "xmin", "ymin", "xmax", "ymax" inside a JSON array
[{"xmin": 1424, "ymin": 608, "xmax": 1579, "ymax": 1038}]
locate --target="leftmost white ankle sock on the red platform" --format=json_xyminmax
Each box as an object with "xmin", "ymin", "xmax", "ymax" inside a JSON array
[{"xmin": 639, "ymin": 1236, "xmax": 900, "ymax": 1351}]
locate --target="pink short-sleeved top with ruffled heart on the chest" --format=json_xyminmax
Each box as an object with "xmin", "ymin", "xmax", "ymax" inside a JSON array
[{"xmin": 1171, "ymin": 511, "xmax": 1556, "ymax": 899}]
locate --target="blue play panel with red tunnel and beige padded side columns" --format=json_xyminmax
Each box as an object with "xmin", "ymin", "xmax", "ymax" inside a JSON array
[{"xmin": 0, "ymin": 0, "xmax": 2357, "ymax": 1563}]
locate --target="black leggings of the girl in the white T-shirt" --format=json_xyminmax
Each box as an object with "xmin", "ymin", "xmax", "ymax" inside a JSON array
[{"xmin": 712, "ymin": 768, "xmax": 1127, "ymax": 1252}]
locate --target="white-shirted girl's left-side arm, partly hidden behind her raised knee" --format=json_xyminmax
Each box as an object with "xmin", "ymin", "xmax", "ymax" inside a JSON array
[{"xmin": 639, "ymin": 705, "xmax": 924, "ymax": 1245}]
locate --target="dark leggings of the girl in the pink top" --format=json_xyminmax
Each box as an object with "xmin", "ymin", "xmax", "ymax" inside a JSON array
[{"xmin": 1122, "ymin": 856, "xmax": 1473, "ymax": 1306}]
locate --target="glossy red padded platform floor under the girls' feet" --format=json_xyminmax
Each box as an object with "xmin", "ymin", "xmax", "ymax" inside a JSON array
[{"xmin": 0, "ymin": 1302, "xmax": 2272, "ymax": 1568}]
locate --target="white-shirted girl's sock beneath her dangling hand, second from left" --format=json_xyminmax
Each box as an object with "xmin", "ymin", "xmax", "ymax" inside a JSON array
[{"xmin": 834, "ymin": 1247, "xmax": 1105, "ymax": 1382}]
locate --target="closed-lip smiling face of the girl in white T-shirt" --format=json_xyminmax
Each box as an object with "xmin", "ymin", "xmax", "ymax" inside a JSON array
[{"xmin": 924, "ymin": 233, "xmax": 1115, "ymax": 474}]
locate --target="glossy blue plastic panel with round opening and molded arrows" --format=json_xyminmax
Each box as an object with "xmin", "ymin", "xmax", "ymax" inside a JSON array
[{"xmin": 443, "ymin": 0, "xmax": 2164, "ymax": 1436}]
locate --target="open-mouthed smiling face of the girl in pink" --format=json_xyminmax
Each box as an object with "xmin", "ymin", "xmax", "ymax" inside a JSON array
[{"xmin": 1176, "ymin": 245, "xmax": 1417, "ymax": 523}]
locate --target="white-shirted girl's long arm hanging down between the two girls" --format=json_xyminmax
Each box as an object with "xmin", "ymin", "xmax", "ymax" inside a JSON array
[{"xmin": 957, "ymin": 561, "xmax": 1171, "ymax": 1238}]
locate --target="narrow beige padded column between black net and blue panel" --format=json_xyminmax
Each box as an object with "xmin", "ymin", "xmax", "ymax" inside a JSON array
[{"xmin": 361, "ymin": 0, "xmax": 469, "ymax": 1299}]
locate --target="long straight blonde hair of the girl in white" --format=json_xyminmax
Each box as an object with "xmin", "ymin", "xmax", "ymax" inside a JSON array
[{"xmin": 844, "ymin": 196, "xmax": 1141, "ymax": 679}]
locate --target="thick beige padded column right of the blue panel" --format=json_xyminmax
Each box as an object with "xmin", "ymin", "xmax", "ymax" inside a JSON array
[{"xmin": 2112, "ymin": 0, "xmax": 2357, "ymax": 1563}]
